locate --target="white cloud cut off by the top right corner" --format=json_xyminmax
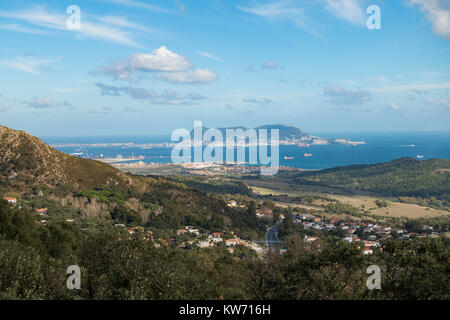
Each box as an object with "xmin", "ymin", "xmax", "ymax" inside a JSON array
[{"xmin": 409, "ymin": 0, "xmax": 450, "ymax": 40}]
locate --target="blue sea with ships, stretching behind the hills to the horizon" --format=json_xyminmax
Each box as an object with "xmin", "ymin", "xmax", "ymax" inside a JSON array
[{"xmin": 43, "ymin": 131, "xmax": 450, "ymax": 169}]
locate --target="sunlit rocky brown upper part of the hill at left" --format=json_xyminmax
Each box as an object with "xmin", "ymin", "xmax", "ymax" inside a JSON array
[{"xmin": 0, "ymin": 126, "xmax": 143, "ymax": 192}]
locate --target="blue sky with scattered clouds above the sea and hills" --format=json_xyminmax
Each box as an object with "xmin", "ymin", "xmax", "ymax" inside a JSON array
[{"xmin": 0, "ymin": 0, "xmax": 450, "ymax": 137}]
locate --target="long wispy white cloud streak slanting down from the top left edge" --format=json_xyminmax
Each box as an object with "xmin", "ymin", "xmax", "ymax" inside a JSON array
[{"xmin": 0, "ymin": 6, "xmax": 140, "ymax": 47}]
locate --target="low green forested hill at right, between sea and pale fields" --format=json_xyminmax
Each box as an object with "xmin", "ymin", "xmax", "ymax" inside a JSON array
[{"xmin": 295, "ymin": 158, "xmax": 450, "ymax": 198}]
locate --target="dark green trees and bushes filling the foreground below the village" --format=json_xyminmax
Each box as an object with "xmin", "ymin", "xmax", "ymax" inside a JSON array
[{"xmin": 0, "ymin": 201, "xmax": 450, "ymax": 299}]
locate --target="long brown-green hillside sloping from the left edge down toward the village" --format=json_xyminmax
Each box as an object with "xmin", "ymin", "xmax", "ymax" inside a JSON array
[{"xmin": 0, "ymin": 127, "xmax": 261, "ymax": 238}]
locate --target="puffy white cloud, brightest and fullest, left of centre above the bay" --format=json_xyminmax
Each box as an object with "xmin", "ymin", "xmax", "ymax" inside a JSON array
[{"xmin": 99, "ymin": 46, "xmax": 191, "ymax": 80}]
